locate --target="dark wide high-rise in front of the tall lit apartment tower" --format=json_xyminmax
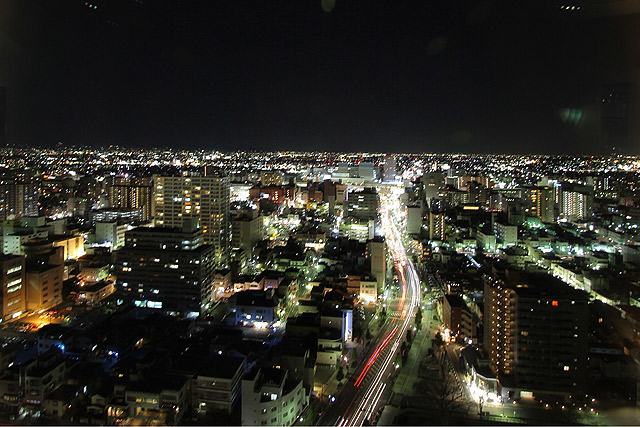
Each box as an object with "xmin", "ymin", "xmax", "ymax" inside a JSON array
[{"xmin": 115, "ymin": 220, "xmax": 220, "ymax": 315}]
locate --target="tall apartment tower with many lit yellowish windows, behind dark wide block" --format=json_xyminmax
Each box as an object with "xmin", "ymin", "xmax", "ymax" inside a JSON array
[{"xmin": 153, "ymin": 175, "xmax": 230, "ymax": 262}]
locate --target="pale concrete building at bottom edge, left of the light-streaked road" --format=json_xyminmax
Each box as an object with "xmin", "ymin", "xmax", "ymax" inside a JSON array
[{"xmin": 242, "ymin": 367, "xmax": 309, "ymax": 426}]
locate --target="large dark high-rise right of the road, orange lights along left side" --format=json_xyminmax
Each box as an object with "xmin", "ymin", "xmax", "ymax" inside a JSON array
[{"xmin": 484, "ymin": 274, "xmax": 589, "ymax": 399}]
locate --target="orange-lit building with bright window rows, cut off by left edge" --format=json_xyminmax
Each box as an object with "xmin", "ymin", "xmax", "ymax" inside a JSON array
[{"xmin": 0, "ymin": 255, "xmax": 27, "ymax": 321}]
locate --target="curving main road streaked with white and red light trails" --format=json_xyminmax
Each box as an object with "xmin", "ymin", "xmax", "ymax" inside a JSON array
[{"xmin": 318, "ymin": 195, "xmax": 420, "ymax": 426}]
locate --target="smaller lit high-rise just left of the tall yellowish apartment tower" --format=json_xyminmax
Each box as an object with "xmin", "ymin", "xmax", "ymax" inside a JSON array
[{"xmin": 108, "ymin": 178, "xmax": 153, "ymax": 221}]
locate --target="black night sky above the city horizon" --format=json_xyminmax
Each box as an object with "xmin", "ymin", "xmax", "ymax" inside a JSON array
[{"xmin": 0, "ymin": 0, "xmax": 637, "ymax": 154}]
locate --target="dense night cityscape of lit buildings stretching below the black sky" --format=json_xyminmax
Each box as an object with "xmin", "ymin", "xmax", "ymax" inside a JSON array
[{"xmin": 0, "ymin": 145, "xmax": 640, "ymax": 426}]
